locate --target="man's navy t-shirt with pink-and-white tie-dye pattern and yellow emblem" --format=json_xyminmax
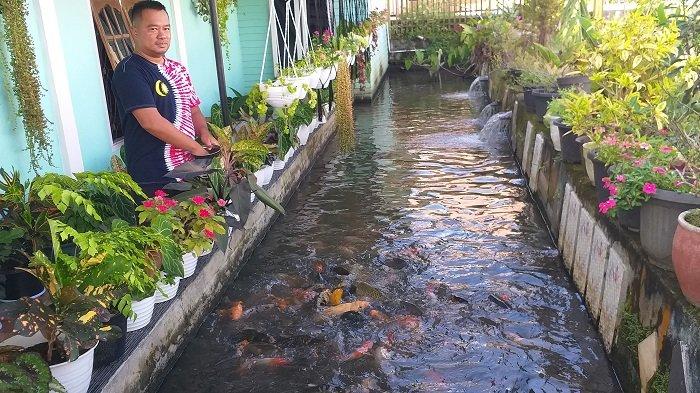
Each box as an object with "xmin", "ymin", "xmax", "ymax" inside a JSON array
[{"xmin": 112, "ymin": 54, "xmax": 200, "ymax": 195}]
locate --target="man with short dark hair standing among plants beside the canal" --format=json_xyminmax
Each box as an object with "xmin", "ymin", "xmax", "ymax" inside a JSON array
[{"xmin": 112, "ymin": 1, "xmax": 218, "ymax": 196}]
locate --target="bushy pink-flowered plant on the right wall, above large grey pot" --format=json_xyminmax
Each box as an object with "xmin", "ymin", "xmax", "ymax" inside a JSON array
[{"xmin": 598, "ymin": 139, "xmax": 693, "ymax": 217}]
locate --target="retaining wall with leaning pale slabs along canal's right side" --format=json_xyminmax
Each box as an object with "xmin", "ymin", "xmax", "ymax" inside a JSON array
[{"xmin": 489, "ymin": 72, "xmax": 700, "ymax": 393}]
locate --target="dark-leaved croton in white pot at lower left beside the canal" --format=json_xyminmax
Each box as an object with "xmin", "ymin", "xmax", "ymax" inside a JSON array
[{"xmin": 0, "ymin": 241, "xmax": 121, "ymax": 392}]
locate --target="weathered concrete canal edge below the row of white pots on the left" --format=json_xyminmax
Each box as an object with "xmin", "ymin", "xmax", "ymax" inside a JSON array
[{"xmin": 90, "ymin": 116, "xmax": 335, "ymax": 393}]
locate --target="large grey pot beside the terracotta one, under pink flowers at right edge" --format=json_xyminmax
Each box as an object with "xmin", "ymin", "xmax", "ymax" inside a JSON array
[{"xmin": 639, "ymin": 190, "xmax": 700, "ymax": 264}]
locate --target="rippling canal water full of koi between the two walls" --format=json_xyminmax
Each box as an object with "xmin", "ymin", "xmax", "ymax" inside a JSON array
[{"xmin": 161, "ymin": 75, "xmax": 616, "ymax": 392}]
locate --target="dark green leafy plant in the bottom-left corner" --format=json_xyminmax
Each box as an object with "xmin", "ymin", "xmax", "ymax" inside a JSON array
[{"xmin": 0, "ymin": 347, "xmax": 66, "ymax": 393}]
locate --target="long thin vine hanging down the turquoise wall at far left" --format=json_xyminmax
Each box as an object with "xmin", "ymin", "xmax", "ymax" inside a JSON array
[{"xmin": 0, "ymin": 0, "xmax": 52, "ymax": 172}]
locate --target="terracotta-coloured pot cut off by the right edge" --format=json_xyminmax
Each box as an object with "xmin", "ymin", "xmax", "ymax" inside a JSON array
[{"xmin": 672, "ymin": 211, "xmax": 700, "ymax": 307}]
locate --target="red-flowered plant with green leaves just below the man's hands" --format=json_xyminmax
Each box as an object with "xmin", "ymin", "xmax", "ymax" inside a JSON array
[{"xmin": 136, "ymin": 190, "xmax": 226, "ymax": 255}]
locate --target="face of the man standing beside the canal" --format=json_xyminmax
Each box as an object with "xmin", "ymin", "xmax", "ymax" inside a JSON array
[{"xmin": 133, "ymin": 10, "xmax": 170, "ymax": 56}]
